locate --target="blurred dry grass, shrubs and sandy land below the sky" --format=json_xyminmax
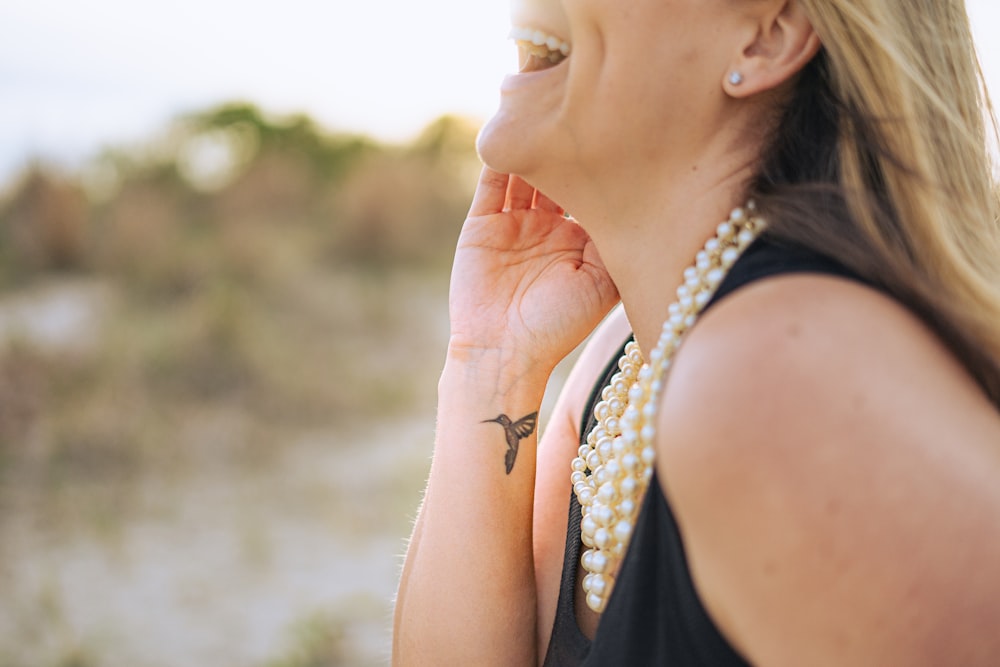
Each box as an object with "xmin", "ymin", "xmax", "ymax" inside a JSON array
[{"xmin": 0, "ymin": 105, "xmax": 476, "ymax": 667}]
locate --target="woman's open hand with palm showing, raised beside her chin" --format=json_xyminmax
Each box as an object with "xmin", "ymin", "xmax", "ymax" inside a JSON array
[{"xmin": 449, "ymin": 167, "xmax": 618, "ymax": 370}]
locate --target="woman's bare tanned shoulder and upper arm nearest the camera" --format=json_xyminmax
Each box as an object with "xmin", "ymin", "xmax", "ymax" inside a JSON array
[{"xmin": 657, "ymin": 275, "xmax": 1000, "ymax": 666}]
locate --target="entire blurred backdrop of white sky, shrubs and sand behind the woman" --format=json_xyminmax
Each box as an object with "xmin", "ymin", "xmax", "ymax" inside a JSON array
[{"xmin": 0, "ymin": 0, "xmax": 1000, "ymax": 667}]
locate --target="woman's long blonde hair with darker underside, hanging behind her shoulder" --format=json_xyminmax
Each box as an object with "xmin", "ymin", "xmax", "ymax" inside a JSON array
[{"xmin": 751, "ymin": 0, "xmax": 1000, "ymax": 407}]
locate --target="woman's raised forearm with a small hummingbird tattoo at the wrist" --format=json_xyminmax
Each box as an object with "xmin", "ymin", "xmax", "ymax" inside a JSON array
[{"xmin": 393, "ymin": 350, "xmax": 548, "ymax": 665}]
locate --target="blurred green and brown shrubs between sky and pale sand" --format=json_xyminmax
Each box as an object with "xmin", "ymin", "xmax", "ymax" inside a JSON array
[{"xmin": 0, "ymin": 104, "xmax": 478, "ymax": 479}]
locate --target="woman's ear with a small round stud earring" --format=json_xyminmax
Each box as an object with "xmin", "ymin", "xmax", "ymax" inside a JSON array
[{"xmin": 722, "ymin": 0, "xmax": 822, "ymax": 98}]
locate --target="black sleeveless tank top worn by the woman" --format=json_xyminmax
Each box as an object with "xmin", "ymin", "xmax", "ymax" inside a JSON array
[{"xmin": 544, "ymin": 237, "xmax": 858, "ymax": 667}]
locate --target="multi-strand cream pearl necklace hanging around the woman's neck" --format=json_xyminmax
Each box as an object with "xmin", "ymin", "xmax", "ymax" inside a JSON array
[{"xmin": 570, "ymin": 201, "xmax": 766, "ymax": 613}]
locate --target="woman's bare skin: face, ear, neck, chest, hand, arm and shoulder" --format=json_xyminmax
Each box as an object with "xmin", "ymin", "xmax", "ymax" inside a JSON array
[{"xmin": 394, "ymin": 0, "xmax": 1000, "ymax": 666}]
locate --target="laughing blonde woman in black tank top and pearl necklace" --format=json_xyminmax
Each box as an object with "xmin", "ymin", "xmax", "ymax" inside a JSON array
[{"xmin": 394, "ymin": 0, "xmax": 1000, "ymax": 666}]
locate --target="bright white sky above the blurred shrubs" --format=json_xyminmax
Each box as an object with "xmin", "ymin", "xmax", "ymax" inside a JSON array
[{"xmin": 0, "ymin": 0, "xmax": 1000, "ymax": 183}]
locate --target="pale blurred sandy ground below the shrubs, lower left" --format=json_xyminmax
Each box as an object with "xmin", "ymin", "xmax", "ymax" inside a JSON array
[{"xmin": 0, "ymin": 418, "xmax": 432, "ymax": 667}]
